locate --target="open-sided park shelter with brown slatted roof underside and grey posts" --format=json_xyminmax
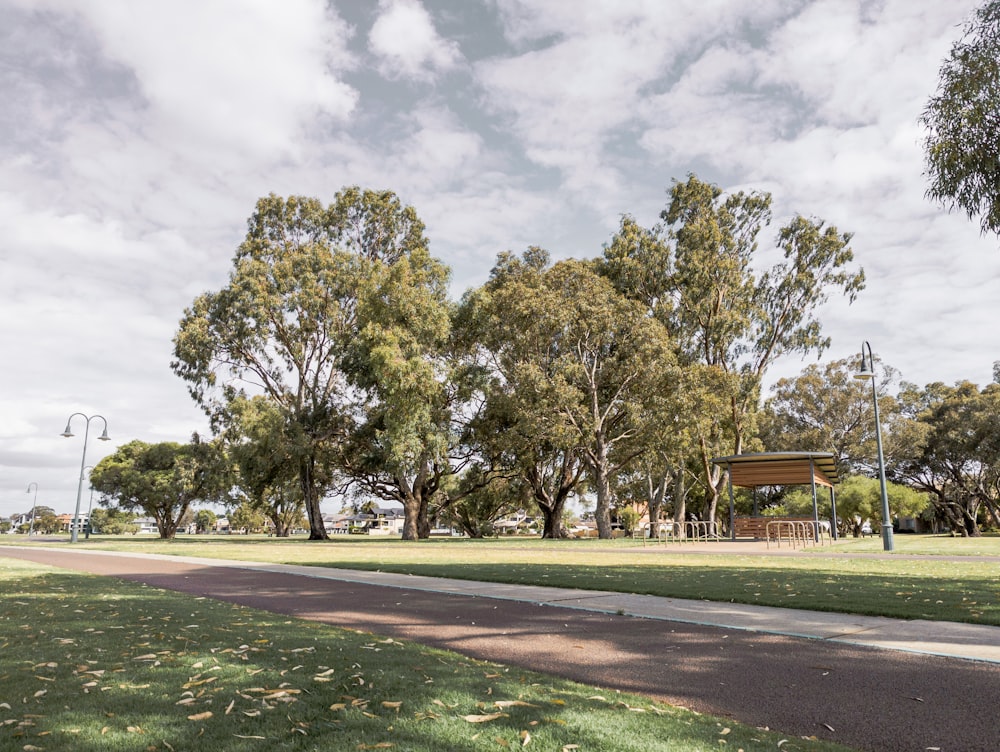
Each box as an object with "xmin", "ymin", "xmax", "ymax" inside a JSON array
[{"xmin": 712, "ymin": 452, "xmax": 840, "ymax": 540}]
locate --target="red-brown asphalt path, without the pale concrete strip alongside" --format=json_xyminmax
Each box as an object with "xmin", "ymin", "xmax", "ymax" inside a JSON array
[{"xmin": 0, "ymin": 548, "xmax": 1000, "ymax": 752}]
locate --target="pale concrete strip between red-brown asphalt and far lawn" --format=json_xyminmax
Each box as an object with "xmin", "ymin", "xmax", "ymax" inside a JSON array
[{"xmin": 21, "ymin": 551, "xmax": 1000, "ymax": 663}]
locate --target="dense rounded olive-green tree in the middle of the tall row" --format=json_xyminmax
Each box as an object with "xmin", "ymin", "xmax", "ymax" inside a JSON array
[{"xmin": 463, "ymin": 248, "xmax": 675, "ymax": 537}]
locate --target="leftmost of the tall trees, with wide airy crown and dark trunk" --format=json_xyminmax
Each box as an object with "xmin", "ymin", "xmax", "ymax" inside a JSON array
[{"xmin": 172, "ymin": 187, "xmax": 438, "ymax": 539}]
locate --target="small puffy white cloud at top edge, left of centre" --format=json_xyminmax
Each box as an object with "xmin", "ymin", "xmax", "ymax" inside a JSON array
[{"xmin": 368, "ymin": 0, "xmax": 461, "ymax": 80}]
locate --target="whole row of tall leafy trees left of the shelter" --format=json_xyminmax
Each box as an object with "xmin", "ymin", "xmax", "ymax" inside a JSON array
[{"xmin": 95, "ymin": 176, "xmax": 852, "ymax": 539}]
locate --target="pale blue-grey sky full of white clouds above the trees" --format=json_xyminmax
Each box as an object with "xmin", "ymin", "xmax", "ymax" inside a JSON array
[{"xmin": 0, "ymin": 0, "xmax": 1000, "ymax": 515}]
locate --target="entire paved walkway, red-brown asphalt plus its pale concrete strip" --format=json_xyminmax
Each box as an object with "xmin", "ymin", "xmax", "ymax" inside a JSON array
[{"xmin": 0, "ymin": 546, "xmax": 1000, "ymax": 752}]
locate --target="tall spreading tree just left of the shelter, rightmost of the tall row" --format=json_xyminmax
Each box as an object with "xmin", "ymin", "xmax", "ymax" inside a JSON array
[{"xmin": 601, "ymin": 175, "xmax": 864, "ymax": 519}]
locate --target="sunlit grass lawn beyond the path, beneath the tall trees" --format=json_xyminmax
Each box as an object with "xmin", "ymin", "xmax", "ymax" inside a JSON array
[{"xmin": 3, "ymin": 536, "xmax": 1000, "ymax": 626}]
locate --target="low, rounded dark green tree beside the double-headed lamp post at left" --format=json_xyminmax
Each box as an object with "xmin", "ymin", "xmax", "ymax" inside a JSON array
[{"xmin": 90, "ymin": 434, "xmax": 232, "ymax": 538}]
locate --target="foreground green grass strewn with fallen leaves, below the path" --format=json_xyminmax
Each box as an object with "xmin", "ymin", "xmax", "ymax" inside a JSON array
[{"xmin": 0, "ymin": 558, "xmax": 844, "ymax": 752}]
